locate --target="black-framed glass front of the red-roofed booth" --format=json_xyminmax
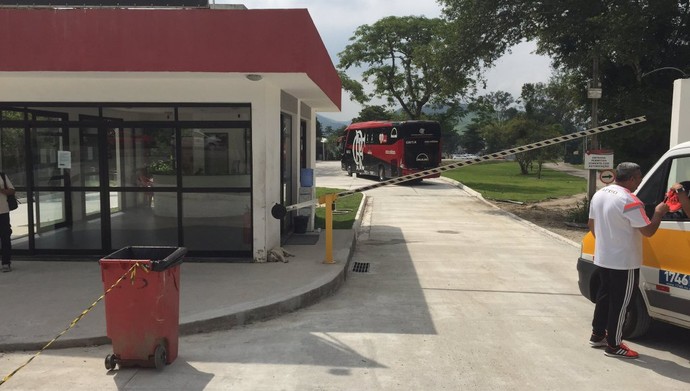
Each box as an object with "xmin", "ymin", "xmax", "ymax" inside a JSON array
[{"xmin": 0, "ymin": 103, "xmax": 253, "ymax": 260}]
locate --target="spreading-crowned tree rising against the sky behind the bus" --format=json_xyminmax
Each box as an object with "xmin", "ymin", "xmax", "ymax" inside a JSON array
[{"xmin": 338, "ymin": 16, "xmax": 478, "ymax": 119}]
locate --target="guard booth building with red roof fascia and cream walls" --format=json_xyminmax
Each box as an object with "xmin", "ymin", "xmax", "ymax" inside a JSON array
[{"xmin": 0, "ymin": 0, "xmax": 341, "ymax": 262}]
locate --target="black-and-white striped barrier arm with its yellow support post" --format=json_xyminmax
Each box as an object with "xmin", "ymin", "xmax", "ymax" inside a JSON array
[{"xmin": 271, "ymin": 116, "xmax": 647, "ymax": 263}]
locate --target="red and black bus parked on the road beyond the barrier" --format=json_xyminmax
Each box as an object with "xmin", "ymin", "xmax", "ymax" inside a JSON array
[{"xmin": 340, "ymin": 121, "xmax": 441, "ymax": 180}]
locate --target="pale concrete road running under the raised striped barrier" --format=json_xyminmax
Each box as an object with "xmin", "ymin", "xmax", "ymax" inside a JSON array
[{"xmin": 1, "ymin": 163, "xmax": 690, "ymax": 391}]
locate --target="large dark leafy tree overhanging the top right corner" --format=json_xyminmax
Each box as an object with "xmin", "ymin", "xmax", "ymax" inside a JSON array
[{"xmin": 441, "ymin": 0, "xmax": 690, "ymax": 167}]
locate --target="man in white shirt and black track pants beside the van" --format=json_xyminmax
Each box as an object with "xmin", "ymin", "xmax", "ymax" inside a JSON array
[{"xmin": 588, "ymin": 162, "xmax": 668, "ymax": 358}]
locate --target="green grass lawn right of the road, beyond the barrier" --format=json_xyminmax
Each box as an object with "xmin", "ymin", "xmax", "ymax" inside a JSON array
[{"xmin": 443, "ymin": 162, "xmax": 587, "ymax": 202}]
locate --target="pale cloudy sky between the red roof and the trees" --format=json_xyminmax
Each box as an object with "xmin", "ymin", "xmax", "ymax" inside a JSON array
[{"xmin": 223, "ymin": 0, "xmax": 551, "ymax": 121}]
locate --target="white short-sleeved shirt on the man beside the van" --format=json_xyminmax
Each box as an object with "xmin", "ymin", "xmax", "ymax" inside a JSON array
[{"xmin": 589, "ymin": 184, "xmax": 650, "ymax": 270}]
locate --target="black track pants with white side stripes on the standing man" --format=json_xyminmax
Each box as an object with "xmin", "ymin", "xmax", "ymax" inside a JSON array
[{"xmin": 592, "ymin": 267, "xmax": 640, "ymax": 346}]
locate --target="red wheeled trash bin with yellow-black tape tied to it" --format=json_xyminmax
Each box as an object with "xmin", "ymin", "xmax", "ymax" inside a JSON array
[{"xmin": 100, "ymin": 246, "xmax": 187, "ymax": 370}]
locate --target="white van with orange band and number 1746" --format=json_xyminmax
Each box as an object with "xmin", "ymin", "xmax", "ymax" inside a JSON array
[{"xmin": 577, "ymin": 142, "xmax": 690, "ymax": 339}]
